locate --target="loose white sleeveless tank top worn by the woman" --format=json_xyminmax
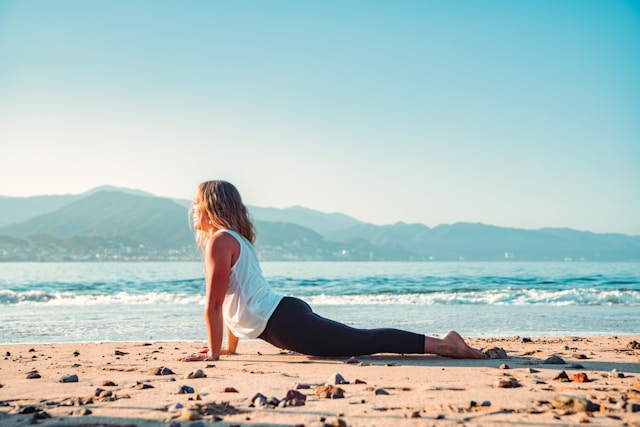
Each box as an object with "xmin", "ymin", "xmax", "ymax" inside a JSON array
[{"xmin": 220, "ymin": 230, "xmax": 282, "ymax": 338}]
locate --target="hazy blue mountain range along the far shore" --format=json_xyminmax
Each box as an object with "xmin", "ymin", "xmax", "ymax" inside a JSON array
[{"xmin": 0, "ymin": 186, "xmax": 640, "ymax": 261}]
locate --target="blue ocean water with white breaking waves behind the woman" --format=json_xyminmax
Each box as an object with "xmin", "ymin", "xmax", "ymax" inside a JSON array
[{"xmin": 0, "ymin": 262, "xmax": 640, "ymax": 344}]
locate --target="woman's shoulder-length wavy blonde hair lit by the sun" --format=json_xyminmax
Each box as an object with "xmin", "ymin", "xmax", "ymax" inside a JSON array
[{"xmin": 193, "ymin": 180, "xmax": 256, "ymax": 250}]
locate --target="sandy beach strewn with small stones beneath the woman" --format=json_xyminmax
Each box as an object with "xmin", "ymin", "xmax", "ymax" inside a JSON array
[{"xmin": 0, "ymin": 336, "xmax": 640, "ymax": 427}]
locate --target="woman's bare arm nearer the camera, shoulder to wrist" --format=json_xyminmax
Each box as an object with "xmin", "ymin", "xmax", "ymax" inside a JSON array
[{"xmin": 204, "ymin": 233, "xmax": 240, "ymax": 360}]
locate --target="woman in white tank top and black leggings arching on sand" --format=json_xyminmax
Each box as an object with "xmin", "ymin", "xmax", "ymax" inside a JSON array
[{"xmin": 180, "ymin": 181, "xmax": 483, "ymax": 361}]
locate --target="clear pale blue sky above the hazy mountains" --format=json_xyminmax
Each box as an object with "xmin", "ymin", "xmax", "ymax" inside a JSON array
[{"xmin": 0, "ymin": 0, "xmax": 640, "ymax": 234}]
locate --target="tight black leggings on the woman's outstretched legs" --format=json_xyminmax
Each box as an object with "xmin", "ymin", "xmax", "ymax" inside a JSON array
[{"xmin": 258, "ymin": 297, "xmax": 424, "ymax": 357}]
